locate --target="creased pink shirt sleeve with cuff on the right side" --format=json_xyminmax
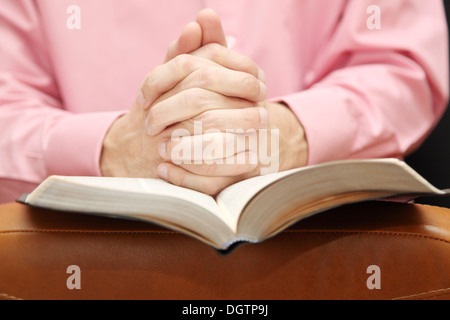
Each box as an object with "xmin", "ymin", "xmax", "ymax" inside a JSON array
[{"xmin": 279, "ymin": 0, "xmax": 448, "ymax": 164}]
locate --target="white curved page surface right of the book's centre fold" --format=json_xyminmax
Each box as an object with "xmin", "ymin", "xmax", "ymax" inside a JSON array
[{"xmin": 216, "ymin": 169, "xmax": 302, "ymax": 232}]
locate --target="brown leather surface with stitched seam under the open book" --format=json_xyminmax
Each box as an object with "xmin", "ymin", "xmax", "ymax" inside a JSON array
[{"xmin": 0, "ymin": 202, "xmax": 450, "ymax": 300}]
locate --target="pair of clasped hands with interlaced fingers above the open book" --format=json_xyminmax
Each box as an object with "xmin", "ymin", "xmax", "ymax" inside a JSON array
[{"xmin": 100, "ymin": 10, "xmax": 307, "ymax": 195}]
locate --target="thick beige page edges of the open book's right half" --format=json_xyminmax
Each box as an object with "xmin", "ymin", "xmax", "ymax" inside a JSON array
[{"xmin": 238, "ymin": 159, "xmax": 443, "ymax": 239}]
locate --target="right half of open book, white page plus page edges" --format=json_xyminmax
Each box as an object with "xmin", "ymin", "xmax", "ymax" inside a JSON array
[{"xmin": 216, "ymin": 159, "xmax": 442, "ymax": 234}]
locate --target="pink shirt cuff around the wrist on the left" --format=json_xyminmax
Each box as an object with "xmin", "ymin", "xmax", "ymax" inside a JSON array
[{"xmin": 44, "ymin": 111, "xmax": 126, "ymax": 176}]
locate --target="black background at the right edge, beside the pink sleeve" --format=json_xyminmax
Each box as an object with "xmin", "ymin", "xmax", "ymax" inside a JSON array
[{"xmin": 405, "ymin": 0, "xmax": 450, "ymax": 208}]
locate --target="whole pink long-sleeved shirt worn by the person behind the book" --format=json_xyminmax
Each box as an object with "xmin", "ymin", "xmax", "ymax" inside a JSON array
[{"xmin": 0, "ymin": 0, "xmax": 448, "ymax": 202}]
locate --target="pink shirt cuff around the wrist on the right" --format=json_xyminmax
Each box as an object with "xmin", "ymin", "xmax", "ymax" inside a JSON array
[{"xmin": 275, "ymin": 87, "xmax": 358, "ymax": 165}]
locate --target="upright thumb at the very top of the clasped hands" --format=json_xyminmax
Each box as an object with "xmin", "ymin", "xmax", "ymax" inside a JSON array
[{"xmin": 197, "ymin": 9, "xmax": 227, "ymax": 47}]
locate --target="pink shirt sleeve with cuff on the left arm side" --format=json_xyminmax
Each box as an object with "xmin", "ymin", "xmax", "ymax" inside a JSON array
[{"xmin": 0, "ymin": 1, "xmax": 122, "ymax": 184}]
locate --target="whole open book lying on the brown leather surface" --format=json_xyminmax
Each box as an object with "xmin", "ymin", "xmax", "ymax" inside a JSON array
[{"xmin": 19, "ymin": 159, "xmax": 449, "ymax": 252}]
